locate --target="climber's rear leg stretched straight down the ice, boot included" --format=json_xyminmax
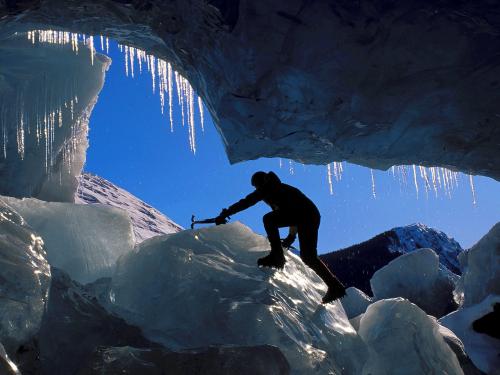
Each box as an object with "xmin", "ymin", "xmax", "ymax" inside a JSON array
[{"xmin": 298, "ymin": 217, "xmax": 345, "ymax": 302}]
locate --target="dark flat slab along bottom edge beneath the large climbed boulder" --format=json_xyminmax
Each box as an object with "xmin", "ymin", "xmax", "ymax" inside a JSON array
[{"xmin": 78, "ymin": 345, "xmax": 290, "ymax": 375}]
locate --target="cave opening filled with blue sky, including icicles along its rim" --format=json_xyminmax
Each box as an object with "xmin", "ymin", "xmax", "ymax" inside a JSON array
[{"xmin": 5, "ymin": 33, "xmax": 498, "ymax": 253}]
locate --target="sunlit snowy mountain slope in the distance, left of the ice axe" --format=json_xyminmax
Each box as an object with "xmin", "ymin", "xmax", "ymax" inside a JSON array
[{"xmin": 75, "ymin": 173, "xmax": 183, "ymax": 243}]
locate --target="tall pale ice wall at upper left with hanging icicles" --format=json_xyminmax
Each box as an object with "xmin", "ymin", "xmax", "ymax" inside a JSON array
[{"xmin": 0, "ymin": 33, "xmax": 111, "ymax": 202}]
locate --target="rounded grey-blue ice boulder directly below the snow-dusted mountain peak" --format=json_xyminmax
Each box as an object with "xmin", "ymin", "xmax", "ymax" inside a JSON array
[{"xmin": 370, "ymin": 249, "xmax": 457, "ymax": 317}]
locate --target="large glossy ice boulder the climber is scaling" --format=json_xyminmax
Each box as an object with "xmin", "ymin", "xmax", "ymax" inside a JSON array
[{"xmin": 111, "ymin": 223, "xmax": 365, "ymax": 374}]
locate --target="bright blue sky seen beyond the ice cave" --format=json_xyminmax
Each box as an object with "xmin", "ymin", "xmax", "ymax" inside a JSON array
[{"xmin": 85, "ymin": 43, "xmax": 500, "ymax": 253}]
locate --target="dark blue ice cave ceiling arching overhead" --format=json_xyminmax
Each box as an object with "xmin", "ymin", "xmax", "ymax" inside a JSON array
[{"xmin": 0, "ymin": 0, "xmax": 500, "ymax": 180}]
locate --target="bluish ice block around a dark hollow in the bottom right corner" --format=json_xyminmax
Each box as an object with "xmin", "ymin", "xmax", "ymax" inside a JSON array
[{"xmin": 439, "ymin": 295, "xmax": 500, "ymax": 374}]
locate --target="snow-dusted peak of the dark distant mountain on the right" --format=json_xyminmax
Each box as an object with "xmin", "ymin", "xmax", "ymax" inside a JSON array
[{"xmin": 389, "ymin": 223, "xmax": 463, "ymax": 274}]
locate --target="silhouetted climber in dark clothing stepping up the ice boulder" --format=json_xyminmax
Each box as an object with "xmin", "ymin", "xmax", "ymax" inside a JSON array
[{"xmin": 216, "ymin": 172, "xmax": 345, "ymax": 303}]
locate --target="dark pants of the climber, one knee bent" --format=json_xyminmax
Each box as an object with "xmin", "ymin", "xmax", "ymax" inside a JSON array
[{"xmin": 263, "ymin": 210, "xmax": 341, "ymax": 287}]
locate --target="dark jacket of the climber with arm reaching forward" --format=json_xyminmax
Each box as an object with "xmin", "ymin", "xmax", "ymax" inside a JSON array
[{"xmin": 226, "ymin": 172, "xmax": 319, "ymax": 219}]
